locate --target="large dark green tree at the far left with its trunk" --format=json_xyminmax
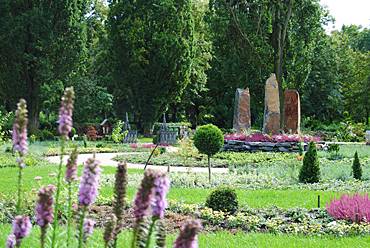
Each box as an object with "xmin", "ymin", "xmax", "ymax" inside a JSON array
[{"xmin": 0, "ymin": 0, "xmax": 89, "ymax": 131}]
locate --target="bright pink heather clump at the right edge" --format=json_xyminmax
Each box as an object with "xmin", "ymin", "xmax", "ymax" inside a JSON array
[{"xmin": 326, "ymin": 194, "xmax": 370, "ymax": 223}]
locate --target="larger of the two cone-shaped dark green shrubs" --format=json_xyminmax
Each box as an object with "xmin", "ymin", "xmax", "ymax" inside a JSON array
[{"xmin": 299, "ymin": 142, "xmax": 320, "ymax": 183}]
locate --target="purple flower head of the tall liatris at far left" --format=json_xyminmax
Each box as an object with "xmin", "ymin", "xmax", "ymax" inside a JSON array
[{"xmin": 13, "ymin": 99, "xmax": 28, "ymax": 156}]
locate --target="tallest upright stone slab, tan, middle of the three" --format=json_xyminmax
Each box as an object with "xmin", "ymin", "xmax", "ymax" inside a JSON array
[{"xmin": 263, "ymin": 73, "xmax": 280, "ymax": 134}]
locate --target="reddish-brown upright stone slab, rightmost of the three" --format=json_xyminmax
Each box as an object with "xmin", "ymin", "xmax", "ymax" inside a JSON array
[{"xmin": 284, "ymin": 90, "xmax": 301, "ymax": 134}]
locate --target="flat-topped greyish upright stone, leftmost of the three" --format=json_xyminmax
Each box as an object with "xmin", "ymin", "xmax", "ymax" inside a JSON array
[{"xmin": 233, "ymin": 88, "xmax": 251, "ymax": 133}]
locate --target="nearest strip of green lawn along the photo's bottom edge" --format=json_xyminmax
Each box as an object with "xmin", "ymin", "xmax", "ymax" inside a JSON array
[{"xmin": 0, "ymin": 225, "xmax": 370, "ymax": 248}]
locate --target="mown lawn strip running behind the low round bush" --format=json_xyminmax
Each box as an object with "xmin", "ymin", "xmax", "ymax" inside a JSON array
[{"xmin": 0, "ymin": 165, "xmax": 341, "ymax": 208}]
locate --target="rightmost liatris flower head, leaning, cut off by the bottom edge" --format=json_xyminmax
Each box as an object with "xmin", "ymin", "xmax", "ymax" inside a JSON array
[{"xmin": 174, "ymin": 220, "xmax": 202, "ymax": 248}]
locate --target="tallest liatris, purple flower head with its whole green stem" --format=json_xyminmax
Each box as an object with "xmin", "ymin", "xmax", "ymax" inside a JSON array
[{"xmin": 51, "ymin": 87, "xmax": 75, "ymax": 248}]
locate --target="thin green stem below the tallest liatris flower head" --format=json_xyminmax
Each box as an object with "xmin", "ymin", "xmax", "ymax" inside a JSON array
[{"xmin": 51, "ymin": 136, "xmax": 65, "ymax": 248}]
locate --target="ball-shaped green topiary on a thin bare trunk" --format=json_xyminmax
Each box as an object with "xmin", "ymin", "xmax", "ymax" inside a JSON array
[{"xmin": 194, "ymin": 124, "xmax": 224, "ymax": 182}]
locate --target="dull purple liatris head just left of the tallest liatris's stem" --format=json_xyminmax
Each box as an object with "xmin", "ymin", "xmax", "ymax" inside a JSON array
[{"xmin": 35, "ymin": 185, "xmax": 55, "ymax": 228}]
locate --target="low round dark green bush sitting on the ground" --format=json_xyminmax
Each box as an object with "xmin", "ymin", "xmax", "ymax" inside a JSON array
[{"xmin": 206, "ymin": 187, "xmax": 238, "ymax": 214}]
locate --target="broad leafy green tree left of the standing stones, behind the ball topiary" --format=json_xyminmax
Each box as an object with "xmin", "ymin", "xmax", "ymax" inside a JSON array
[{"xmin": 108, "ymin": 0, "xmax": 196, "ymax": 133}]
